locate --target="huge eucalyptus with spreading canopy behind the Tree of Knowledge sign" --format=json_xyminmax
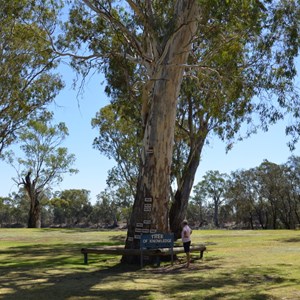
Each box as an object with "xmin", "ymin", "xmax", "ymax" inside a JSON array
[{"xmin": 54, "ymin": 0, "xmax": 299, "ymax": 262}]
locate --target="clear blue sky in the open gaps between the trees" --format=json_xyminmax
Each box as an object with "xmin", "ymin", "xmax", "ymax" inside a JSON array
[{"xmin": 0, "ymin": 65, "xmax": 300, "ymax": 203}]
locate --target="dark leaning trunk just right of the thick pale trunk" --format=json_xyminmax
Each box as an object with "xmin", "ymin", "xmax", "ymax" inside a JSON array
[{"xmin": 170, "ymin": 135, "xmax": 206, "ymax": 239}]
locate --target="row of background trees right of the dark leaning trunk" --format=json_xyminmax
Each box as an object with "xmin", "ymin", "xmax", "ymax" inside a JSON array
[{"xmin": 192, "ymin": 156, "xmax": 300, "ymax": 229}]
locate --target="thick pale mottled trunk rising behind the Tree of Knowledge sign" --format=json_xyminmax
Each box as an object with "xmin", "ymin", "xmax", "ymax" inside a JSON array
[{"xmin": 122, "ymin": 0, "xmax": 198, "ymax": 263}]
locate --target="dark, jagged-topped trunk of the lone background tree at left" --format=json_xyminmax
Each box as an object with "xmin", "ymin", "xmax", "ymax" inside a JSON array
[{"xmin": 23, "ymin": 172, "xmax": 41, "ymax": 228}]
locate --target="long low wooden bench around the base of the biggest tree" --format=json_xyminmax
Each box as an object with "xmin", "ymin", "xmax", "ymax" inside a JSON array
[{"xmin": 81, "ymin": 245, "xmax": 206, "ymax": 264}]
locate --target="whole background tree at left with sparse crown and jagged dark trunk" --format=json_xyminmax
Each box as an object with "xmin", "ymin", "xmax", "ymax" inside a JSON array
[{"xmin": 10, "ymin": 113, "xmax": 77, "ymax": 228}]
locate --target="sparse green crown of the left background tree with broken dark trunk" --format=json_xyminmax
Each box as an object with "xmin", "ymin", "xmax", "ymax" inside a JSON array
[{"xmin": 11, "ymin": 113, "xmax": 78, "ymax": 195}]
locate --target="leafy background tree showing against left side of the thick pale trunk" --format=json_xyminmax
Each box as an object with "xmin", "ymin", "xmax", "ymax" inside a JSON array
[{"xmin": 92, "ymin": 103, "xmax": 141, "ymax": 198}]
